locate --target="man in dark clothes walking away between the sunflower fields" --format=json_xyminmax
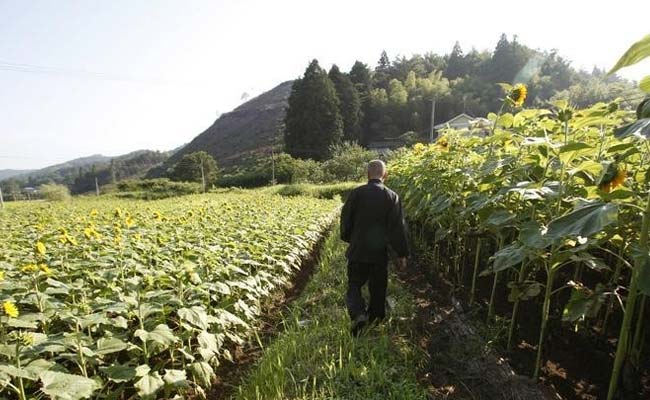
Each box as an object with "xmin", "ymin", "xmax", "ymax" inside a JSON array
[{"xmin": 341, "ymin": 160, "xmax": 408, "ymax": 336}]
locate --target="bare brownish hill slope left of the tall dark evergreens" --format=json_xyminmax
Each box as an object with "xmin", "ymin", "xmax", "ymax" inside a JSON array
[{"xmin": 157, "ymin": 81, "xmax": 293, "ymax": 175}]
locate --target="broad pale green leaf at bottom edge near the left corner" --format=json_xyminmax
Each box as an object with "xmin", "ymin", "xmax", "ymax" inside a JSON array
[{"xmin": 39, "ymin": 371, "xmax": 101, "ymax": 400}]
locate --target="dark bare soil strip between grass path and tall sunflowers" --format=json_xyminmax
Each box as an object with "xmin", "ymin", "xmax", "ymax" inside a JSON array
[{"xmin": 397, "ymin": 245, "xmax": 562, "ymax": 400}]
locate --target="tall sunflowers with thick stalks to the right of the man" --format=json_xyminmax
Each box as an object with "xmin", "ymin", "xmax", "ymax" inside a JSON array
[{"xmin": 389, "ymin": 36, "xmax": 650, "ymax": 399}]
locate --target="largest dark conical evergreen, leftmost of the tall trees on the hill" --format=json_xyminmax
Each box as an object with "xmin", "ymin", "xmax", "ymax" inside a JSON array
[{"xmin": 284, "ymin": 59, "xmax": 343, "ymax": 160}]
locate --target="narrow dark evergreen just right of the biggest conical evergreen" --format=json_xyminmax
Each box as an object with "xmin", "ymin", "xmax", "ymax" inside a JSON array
[{"xmin": 328, "ymin": 65, "xmax": 361, "ymax": 142}]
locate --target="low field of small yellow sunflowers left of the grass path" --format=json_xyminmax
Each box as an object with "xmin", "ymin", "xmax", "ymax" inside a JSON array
[{"xmin": 0, "ymin": 192, "xmax": 339, "ymax": 400}]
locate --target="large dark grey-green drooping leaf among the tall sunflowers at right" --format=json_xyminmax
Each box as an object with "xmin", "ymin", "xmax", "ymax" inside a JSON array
[{"xmin": 545, "ymin": 203, "xmax": 618, "ymax": 240}]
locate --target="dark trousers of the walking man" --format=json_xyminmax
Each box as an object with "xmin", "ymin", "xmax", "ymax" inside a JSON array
[{"xmin": 345, "ymin": 261, "xmax": 388, "ymax": 321}]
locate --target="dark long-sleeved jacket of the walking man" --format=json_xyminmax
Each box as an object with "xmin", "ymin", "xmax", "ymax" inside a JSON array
[{"xmin": 341, "ymin": 179, "xmax": 408, "ymax": 263}]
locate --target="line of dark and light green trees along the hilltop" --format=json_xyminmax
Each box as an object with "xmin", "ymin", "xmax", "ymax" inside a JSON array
[{"xmin": 284, "ymin": 34, "xmax": 640, "ymax": 160}]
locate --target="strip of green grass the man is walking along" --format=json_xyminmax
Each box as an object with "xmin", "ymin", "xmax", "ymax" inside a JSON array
[{"xmin": 235, "ymin": 227, "xmax": 427, "ymax": 400}]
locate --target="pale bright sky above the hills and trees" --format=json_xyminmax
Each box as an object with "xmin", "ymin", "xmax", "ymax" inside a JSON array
[{"xmin": 0, "ymin": 0, "xmax": 650, "ymax": 169}]
